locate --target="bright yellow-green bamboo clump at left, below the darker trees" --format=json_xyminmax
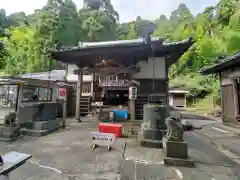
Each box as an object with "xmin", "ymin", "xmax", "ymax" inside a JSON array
[{"xmin": 1, "ymin": 27, "xmax": 49, "ymax": 75}]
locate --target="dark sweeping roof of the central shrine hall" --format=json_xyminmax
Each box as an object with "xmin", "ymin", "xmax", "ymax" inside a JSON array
[{"xmin": 51, "ymin": 38, "xmax": 194, "ymax": 67}]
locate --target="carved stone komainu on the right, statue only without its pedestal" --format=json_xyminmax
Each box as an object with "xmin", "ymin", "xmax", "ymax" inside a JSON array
[{"xmin": 165, "ymin": 117, "xmax": 184, "ymax": 142}]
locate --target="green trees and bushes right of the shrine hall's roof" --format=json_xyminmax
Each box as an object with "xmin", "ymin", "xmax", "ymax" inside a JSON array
[{"xmin": 153, "ymin": 0, "xmax": 240, "ymax": 101}]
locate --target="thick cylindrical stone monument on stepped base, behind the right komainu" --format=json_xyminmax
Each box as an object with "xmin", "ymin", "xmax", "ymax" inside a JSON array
[{"xmin": 138, "ymin": 104, "xmax": 168, "ymax": 148}]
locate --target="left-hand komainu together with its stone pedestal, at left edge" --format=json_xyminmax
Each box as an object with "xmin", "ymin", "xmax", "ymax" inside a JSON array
[{"xmin": 0, "ymin": 112, "xmax": 20, "ymax": 141}]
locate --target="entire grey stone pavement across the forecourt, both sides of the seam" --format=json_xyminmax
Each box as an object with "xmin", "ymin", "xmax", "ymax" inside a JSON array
[{"xmin": 0, "ymin": 117, "xmax": 240, "ymax": 180}]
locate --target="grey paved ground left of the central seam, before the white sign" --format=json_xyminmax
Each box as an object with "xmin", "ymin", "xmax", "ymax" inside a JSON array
[{"xmin": 0, "ymin": 116, "xmax": 125, "ymax": 180}]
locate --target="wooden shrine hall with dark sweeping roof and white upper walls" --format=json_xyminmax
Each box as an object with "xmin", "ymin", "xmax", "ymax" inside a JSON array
[{"xmin": 51, "ymin": 38, "xmax": 193, "ymax": 120}]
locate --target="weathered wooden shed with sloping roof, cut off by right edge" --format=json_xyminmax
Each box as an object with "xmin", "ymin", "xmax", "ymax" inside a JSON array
[{"xmin": 201, "ymin": 53, "xmax": 240, "ymax": 124}]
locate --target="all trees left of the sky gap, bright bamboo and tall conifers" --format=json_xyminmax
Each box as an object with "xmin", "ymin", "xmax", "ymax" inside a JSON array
[{"xmin": 0, "ymin": 0, "xmax": 119, "ymax": 75}]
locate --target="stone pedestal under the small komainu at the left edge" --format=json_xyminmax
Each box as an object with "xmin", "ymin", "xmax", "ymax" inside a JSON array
[{"xmin": 0, "ymin": 125, "xmax": 20, "ymax": 142}]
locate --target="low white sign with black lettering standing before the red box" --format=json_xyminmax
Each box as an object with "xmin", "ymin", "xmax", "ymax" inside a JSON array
[{"xmin": 92, "ymin": 132, "xmax": 116, "ymax": 149}]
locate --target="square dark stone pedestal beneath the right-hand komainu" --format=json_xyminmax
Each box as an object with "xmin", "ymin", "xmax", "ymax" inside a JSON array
[{"xmin": 162, "ymin": 137, "xmax": 194, "ymax": 167}]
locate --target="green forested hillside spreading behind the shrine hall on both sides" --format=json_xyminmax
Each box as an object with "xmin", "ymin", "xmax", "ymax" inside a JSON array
[{"xmin": 0, "ymin": 0, "xmax": 240, "ymax": 105}]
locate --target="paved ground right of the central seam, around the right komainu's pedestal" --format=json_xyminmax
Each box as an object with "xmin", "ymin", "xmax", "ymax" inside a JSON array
[{"xmin": 121, "ymin": 132, "xmax": 240, "ymax": 180}]
